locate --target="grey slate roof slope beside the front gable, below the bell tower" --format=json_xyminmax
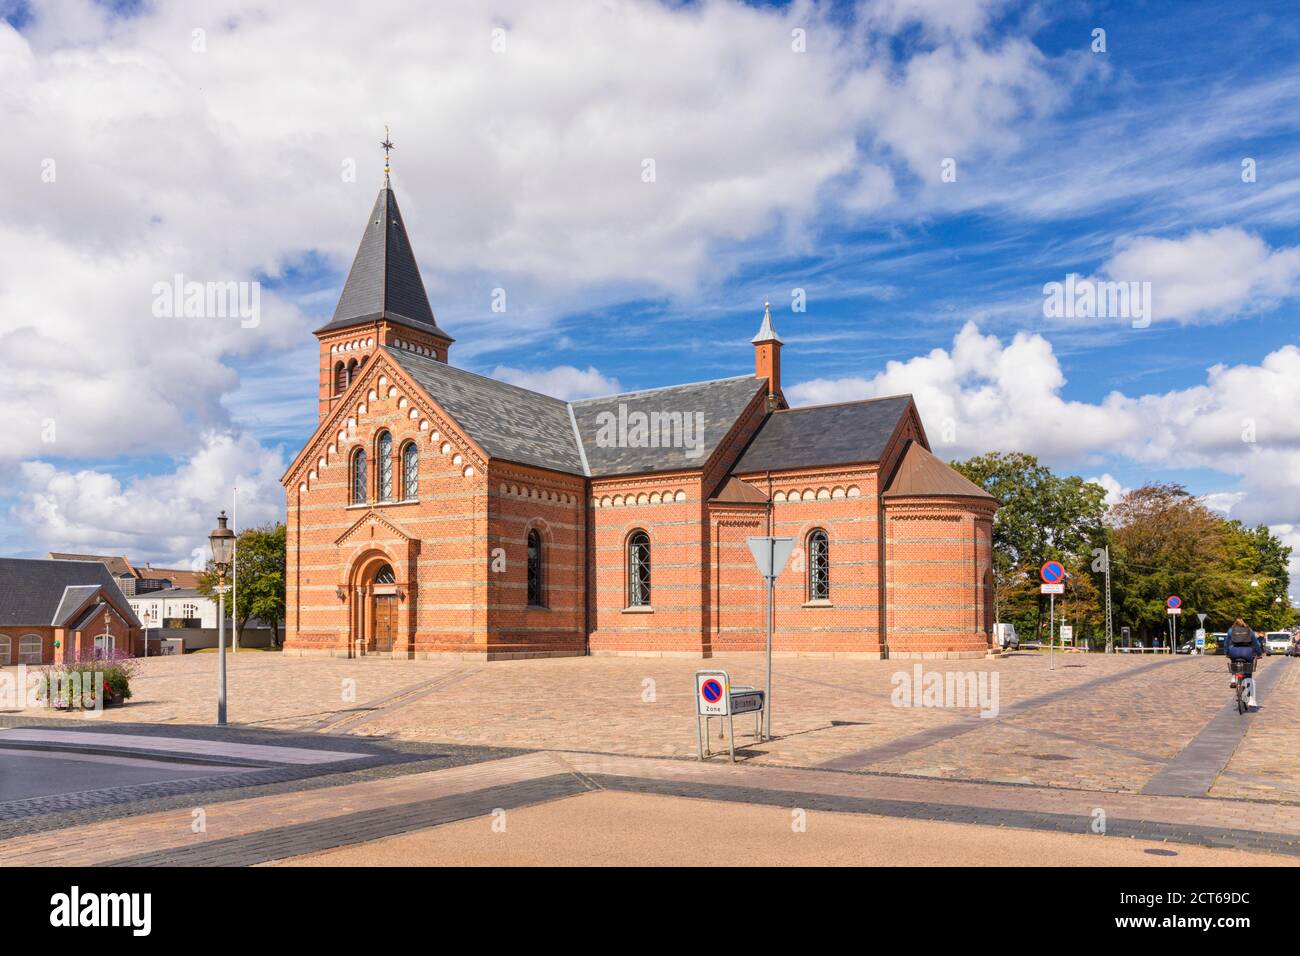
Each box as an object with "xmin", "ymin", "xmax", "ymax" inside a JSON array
[{"xmin": 387, "ymin": 349, "xmax": 582, "ymax": 475}]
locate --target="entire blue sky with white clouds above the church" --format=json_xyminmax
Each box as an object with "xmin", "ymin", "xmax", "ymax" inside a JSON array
[{"xmin": 0, "ymin": 0, "xmax": 1300, "ymax": 580}]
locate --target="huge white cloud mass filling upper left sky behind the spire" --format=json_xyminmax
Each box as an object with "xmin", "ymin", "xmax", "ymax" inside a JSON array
[{"xmin": 0, "ymin": 0, "xmax": 1056, "ymax": 470}]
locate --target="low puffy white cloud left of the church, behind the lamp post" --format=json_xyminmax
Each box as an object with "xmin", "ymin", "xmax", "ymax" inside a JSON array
[{"xmin": 9, "ymin": 433, "xmax": 286, "ymax": 567}]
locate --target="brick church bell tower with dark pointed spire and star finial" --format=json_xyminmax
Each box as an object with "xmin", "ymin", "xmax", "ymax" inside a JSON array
[{"xmin": 315, "ymin": 140, "xmax": 455, "ymax": 420}]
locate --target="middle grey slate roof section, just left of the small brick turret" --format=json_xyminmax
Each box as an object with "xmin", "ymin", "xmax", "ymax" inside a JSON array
[{"xmin": 572, "ymin": 375, "xmax": 767, "ymax": 477}]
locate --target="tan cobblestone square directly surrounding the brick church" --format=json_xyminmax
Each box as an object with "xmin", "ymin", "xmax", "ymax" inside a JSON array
[{"xmin": 2, "ymin": 653, "xmax": 1300, "ymax": 804}]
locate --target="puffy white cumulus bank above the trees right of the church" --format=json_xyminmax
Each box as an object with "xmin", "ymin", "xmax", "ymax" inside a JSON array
[{"xmin": 785, "ymin": 323, "xmax": 1300, "ymax": 538}]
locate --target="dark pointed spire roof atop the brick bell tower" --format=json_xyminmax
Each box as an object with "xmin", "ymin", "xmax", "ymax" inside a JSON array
[{"xmin": 316, "ymin": 183, "xmax": 451, "ymax": 341}]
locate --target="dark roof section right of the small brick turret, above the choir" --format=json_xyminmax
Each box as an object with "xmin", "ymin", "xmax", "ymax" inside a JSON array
[{"xmin": 732, "ymin": 395, "xmax": 911, "ymax": 475}]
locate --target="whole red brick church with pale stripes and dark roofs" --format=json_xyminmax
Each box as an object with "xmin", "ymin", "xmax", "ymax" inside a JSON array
[{"xmin": 283, "ymin": 182, "xmax": 996, "ymax": 658}]
